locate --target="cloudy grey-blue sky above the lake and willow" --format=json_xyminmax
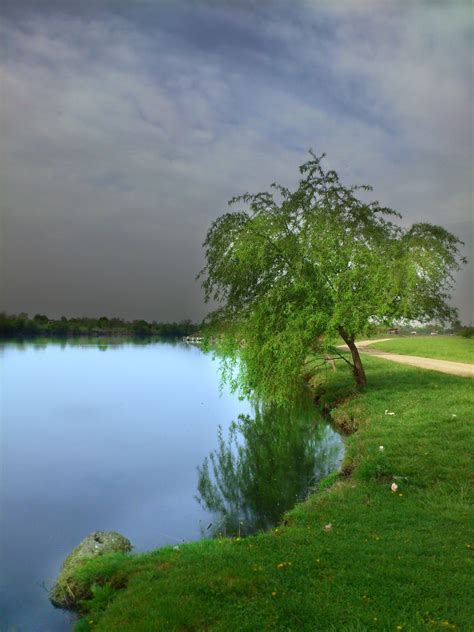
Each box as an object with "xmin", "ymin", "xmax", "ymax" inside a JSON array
[{"xmin": 0, "ymin": 0, "xmax": 474, "ymax": 322}]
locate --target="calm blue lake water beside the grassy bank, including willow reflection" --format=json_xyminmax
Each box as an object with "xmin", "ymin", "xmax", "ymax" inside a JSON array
[{"xmin": 0, "ymin": 342, "xmax": 341, "ymax": 632}]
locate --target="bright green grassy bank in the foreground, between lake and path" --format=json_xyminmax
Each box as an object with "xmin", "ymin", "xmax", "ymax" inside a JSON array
[{"xmin": 71, "ymin": 357, "xmax": 474, "ymax": 632}]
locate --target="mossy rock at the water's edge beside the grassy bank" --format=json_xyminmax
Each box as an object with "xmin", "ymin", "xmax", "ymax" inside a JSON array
[{"xmin": 49, "ymin": 531, "xmax": 132, "ymax": 610}]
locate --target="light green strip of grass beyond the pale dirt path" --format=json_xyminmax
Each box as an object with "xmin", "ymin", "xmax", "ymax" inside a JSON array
[{"xmin": 370, "ymin": 336, "xmax": 474, "ymax": 364}]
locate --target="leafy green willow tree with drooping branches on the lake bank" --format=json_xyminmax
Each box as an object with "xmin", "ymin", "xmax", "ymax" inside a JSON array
[{"xmin": 200, "ymin": 152, "xmax": 464, "ymax": 400}]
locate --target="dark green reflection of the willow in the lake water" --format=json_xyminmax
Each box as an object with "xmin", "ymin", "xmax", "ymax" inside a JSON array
[{"xmin": 197, "ymin": 402, "xmax": 343, "ymax": 536}]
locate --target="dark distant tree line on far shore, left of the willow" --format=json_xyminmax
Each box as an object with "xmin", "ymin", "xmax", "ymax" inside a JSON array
[{"xmin": 0, "ymin": 313, "xmax": 199, "ymax": 338}]
